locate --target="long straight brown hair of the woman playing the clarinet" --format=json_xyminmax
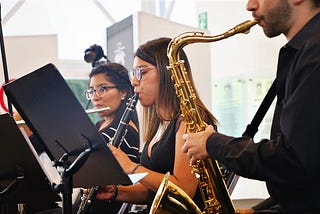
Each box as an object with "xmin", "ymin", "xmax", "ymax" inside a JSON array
[{"xmin": 135, "ymin": 37, "xmax": 217, "ymax": 142}]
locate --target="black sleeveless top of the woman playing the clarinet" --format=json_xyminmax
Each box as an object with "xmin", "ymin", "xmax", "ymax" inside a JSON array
[{"xmin": 140, "ymin": 119, "xmax": 204, "ymax": 210}]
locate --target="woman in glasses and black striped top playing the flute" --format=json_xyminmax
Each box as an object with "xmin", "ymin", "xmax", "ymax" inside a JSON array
[{"xmin": 85, "ymin": 63, "xmax": 140, "ymax": 213}]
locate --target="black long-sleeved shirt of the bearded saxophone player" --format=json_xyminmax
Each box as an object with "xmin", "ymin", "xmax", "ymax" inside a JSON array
[{"xmin": 207, "ymin": 13, "xmax": 320, "ymax": 214}]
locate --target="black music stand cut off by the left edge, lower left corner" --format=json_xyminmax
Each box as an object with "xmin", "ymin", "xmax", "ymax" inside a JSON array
[{"xmin": 0, "ymin": 114, "xmax": 61, "ymax": 213}]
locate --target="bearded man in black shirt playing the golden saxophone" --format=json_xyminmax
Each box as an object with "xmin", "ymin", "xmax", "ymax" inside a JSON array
[{"xmin": 182, "ymin": 0, "xmax": 320, "ymax": 214}]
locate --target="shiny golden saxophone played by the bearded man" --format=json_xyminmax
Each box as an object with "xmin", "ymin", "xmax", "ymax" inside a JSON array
[{"xmin": 150, "ymin": 20, "xmax": 257, "ymax": 214}]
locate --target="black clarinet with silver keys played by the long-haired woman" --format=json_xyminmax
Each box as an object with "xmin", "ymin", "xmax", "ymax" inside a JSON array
[{"xmin": 77, "ymin": 94, "xmax": 139, "ymax": 214}]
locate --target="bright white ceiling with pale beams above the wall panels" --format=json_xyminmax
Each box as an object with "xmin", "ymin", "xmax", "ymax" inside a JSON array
[{"xmin": 1, "ymin": 0, "xmax": 197, "ymax": 59}]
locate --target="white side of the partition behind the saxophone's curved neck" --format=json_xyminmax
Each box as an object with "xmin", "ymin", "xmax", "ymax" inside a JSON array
[{"xmin": 134, "ymin": 12, "xmax": 212, "ymax": 106}]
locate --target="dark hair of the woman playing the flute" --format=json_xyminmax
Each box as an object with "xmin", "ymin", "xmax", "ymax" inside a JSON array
[{"xmin": 89, "ymin": 63, "xmax": 139, "ymax": 128}]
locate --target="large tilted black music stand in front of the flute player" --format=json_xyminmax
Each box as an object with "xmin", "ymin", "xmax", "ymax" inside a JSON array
[{"xmin": 4, "ymin": 64, "xmax": 132, "ymax": 213}]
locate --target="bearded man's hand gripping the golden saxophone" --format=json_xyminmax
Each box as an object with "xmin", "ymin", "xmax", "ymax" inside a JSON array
[{"xmin": 182, "ymin": 125, "xmax": 216, "ymax": 164}]
